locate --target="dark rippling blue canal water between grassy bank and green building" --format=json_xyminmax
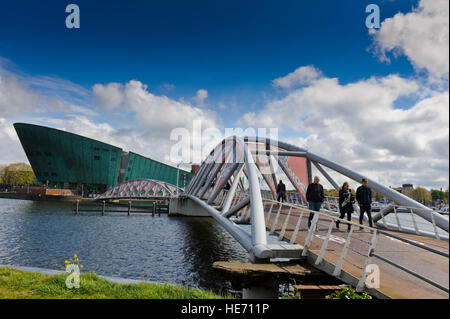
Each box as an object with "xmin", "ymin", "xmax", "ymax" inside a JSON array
[{"xmin": 0, "ymin": 199, "xmax": 247, "ymax": 292}]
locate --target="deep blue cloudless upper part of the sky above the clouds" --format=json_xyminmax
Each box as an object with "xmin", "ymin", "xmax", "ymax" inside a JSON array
[{"xmin": 0, "ymin": 0, "xmax": 417, "ymax": 119}]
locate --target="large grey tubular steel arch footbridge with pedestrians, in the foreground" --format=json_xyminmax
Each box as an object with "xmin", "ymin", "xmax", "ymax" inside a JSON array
[{"xmin": 177, "ymin": 137, "xmax": 449, "ymax": 298}]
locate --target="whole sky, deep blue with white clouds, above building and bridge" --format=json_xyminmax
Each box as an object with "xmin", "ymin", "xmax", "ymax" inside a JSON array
[{"xmin": 0, "ymin": 0, "xmax": 449, "ymax": 188}]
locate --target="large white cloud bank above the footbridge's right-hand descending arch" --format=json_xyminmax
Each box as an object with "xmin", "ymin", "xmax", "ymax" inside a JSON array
[{"xmin": 240, "ymin": 66, "xmax": 449, "ymax": 186}]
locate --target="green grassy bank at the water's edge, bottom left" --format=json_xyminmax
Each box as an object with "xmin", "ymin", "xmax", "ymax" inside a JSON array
[{"xmin": 0, "ymin": 267, "xmax": 232, "ymax": 299}]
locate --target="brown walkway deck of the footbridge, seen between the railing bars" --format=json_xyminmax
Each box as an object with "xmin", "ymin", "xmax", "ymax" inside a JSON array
[{"xmin": 265, "ymin": 204, "xmax": 449, "ymax": 299}]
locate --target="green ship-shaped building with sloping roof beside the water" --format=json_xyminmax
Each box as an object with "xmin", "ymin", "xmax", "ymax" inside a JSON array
[{"xmin": 14, "ymin": 123, "xmax": 193, "ymax": 196}]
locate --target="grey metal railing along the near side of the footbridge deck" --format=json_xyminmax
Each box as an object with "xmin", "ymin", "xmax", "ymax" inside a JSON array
[{"xmin": 238, "ymin": 199, "xmax": 448, "ymax": 293}]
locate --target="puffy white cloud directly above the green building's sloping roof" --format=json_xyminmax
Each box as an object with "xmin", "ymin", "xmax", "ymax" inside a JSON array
[{"xmin": 93, "ymin": 80, "xmax": 222, "ymax": 165}]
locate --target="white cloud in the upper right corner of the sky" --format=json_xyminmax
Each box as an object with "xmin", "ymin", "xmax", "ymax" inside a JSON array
[{"xmin": 371, "ymin": 0, "xmax": 449, "ymax": 77}]
